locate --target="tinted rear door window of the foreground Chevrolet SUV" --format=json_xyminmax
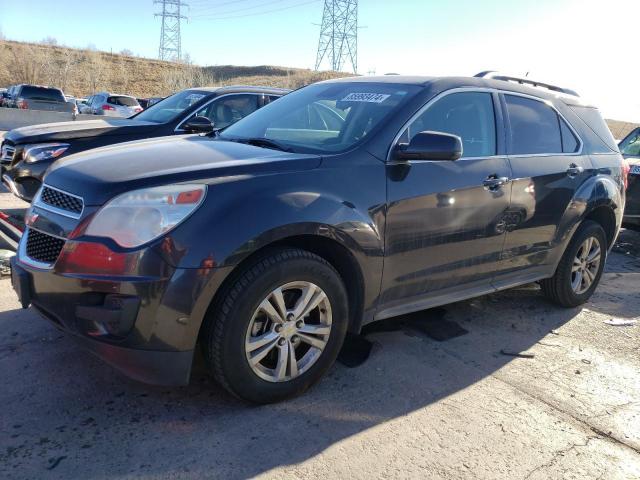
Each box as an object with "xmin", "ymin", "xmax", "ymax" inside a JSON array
[{"xmin": 505, "ymin": 95, "xmax": 562, "ymax": 155}]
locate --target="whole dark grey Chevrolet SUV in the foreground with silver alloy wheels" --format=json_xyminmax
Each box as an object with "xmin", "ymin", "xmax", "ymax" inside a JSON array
[{"xmin": 12, "ymin": 75, "xmax": 625, "ymax": 402}]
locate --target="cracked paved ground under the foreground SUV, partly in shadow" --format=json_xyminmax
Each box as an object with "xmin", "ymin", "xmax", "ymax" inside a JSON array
[{"xmin": 0, "ymin": 189, "xmax": 640, "ymax": 479}]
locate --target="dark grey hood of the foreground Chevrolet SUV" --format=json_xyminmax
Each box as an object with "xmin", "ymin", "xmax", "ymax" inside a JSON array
[{"xmin": 44, "ymin": 135, "xmax": 321, "ymax": 206}]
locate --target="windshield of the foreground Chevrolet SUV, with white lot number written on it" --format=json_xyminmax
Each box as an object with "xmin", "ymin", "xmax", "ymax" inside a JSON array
[{"xmin": 218, "ymin": 82, "xmax": 420, "ymax": 153}]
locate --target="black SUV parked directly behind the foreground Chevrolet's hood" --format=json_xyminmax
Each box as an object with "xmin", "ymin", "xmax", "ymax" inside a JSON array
[{"xmin": 0, "ymin": 86, "xmax": 289, "ymax": 202}]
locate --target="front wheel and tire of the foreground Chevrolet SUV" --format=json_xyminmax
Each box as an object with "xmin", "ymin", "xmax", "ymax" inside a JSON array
[{"xmin": 201, "ymin": 248, "xmax": 348, "ymax": 404}]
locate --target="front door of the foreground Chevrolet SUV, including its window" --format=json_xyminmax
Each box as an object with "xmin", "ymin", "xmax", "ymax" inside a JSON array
[{"xmin": 377, "ymin": 90, "xmax": 511, "ymax": 318}]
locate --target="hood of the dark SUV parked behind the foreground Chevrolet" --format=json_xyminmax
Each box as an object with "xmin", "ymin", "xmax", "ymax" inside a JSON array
[{"xmin": 5, "ymin": 118, "xmax": 160, "ymax": 145}]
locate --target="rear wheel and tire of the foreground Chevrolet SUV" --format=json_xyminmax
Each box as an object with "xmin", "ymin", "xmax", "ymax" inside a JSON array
[{"xmin": 540, "ymin": 220, "xmax": 608, "ymax": 308}]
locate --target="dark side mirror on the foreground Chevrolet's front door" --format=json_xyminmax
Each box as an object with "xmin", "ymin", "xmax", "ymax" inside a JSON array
[{"xmin": 393, "ymin": 132, "xmax": 462, "ymax": 161}]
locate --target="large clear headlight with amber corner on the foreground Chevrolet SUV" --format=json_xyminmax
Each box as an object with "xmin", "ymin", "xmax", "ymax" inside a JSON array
[{"xmin": 80, "ymin": 185, "xmax": 207, "ymax": 248}]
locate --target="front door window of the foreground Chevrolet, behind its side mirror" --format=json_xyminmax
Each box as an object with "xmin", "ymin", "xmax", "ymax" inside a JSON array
[{"xmin": 401, "ymin": 92, "xmax": 496, "ymax": 158}]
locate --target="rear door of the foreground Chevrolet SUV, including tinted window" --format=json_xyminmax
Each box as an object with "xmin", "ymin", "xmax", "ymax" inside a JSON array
[{"xmin": 496, "ymin": 92, "xmax": 591, "ymax": 287}]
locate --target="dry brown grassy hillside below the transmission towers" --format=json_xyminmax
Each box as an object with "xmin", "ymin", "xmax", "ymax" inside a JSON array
[{"xmin": 0, "ymin": 40, "xmax": 346, "ymax": 97}]
